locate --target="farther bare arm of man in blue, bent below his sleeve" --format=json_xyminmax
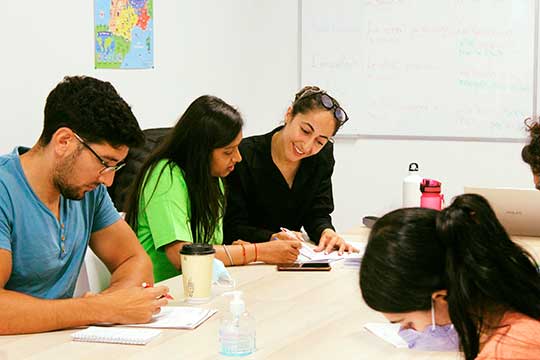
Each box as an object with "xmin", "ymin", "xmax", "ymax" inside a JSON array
[{"xmin": 90, "ymin": 220, "xmax": 154, "ymax": 291}]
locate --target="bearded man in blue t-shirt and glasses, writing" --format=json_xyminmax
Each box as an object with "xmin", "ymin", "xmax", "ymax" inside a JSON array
[{"xmin": 0, "ymin": 76, "xmax": 167, "ymax": 334}]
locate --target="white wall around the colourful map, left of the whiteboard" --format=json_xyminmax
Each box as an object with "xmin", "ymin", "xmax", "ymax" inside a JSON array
[{"xmin": 0, "ymin": 0, "xmax": 298, "ymax": 153}]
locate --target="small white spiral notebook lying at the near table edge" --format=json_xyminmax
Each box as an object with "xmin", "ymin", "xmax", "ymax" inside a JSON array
[{"xmin": 71, "ymin": 326, "xmax": 161, "ymax": 345}]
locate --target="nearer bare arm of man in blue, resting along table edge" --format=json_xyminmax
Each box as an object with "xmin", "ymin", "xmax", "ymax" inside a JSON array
[{"xmin": 0, "ymin": 249, "xmax": 168, "ymax": 335}]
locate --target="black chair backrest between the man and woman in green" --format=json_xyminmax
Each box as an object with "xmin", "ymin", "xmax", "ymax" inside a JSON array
[{"xmin": 108, "ymin": 128, "xmax": 171, "ymax": 211}]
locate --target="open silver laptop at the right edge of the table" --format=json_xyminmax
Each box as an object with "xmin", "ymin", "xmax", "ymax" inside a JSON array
[{"xmin": 465, "ymin": 186, "xmax": 540, "ymax": 236}]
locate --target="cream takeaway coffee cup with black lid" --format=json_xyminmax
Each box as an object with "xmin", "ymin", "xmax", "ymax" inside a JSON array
[{"xmin": 180, "ymin": 244, "xmax": 216, "ymax": 304}]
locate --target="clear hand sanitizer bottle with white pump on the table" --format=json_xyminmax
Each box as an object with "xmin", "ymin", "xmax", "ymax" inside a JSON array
[{"xmin": 219, "ymin": 291, "xmax": 255, "ymax": 356}]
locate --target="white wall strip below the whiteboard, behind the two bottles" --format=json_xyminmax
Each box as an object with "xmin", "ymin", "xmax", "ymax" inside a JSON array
[{"xmin": 333, "ymin": 138, "xmax": 533, "ymax": 229}]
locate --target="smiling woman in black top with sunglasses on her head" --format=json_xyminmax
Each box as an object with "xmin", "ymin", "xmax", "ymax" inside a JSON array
[{"xmin": 223, "ymin": 86, "xmax": 353, "ymax": 253}]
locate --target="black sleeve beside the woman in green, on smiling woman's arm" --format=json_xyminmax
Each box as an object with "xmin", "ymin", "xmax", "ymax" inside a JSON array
[{"xmin": 223, "ymin": 163, "xmax": 273, "ymax": 244}]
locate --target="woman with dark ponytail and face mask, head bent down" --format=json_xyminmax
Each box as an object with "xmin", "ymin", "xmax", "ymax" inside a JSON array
[{"xmin": 360, "ymin": 194, "xmax": 540, "ymax": 360}]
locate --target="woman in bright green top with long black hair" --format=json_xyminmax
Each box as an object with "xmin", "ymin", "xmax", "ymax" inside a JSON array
[{"xmin": 126, "ymin": 95, "xmax": 301, "ymax": 281}]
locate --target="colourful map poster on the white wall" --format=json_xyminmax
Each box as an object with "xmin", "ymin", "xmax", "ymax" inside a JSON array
[{"xmin": 94, "ymin": 0, "xmax": 154, "ymax": 69}]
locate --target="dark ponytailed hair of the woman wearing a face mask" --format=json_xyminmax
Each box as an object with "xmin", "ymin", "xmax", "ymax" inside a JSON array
[{"xmin": 360, "ymin": 194, "xmax": 540, "ymax": 360}]
